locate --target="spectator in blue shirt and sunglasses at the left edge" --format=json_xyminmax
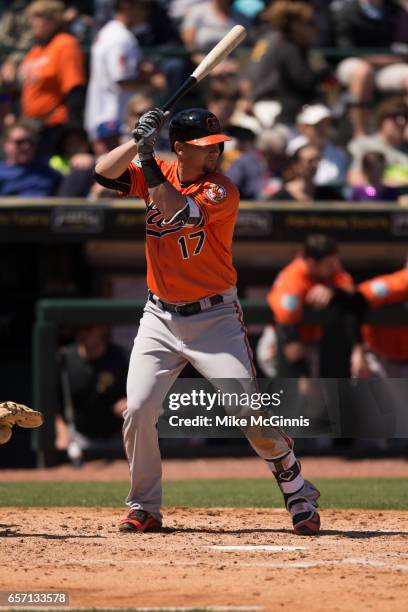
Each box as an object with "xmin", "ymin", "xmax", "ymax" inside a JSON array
[{"xmin": 0, "ymin": 121, "xmax": 61, "ymax": 197}]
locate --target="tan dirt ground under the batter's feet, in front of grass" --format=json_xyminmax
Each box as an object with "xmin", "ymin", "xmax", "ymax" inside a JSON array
[{"xmin": 0, "ymin": 508, "xmax": 408, "ymax": 612}]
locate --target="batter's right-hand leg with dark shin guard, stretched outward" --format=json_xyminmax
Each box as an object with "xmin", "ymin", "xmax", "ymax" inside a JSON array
[{"xmin": 183, "ymin": 294, "xmax": 320, "ymax": 535}]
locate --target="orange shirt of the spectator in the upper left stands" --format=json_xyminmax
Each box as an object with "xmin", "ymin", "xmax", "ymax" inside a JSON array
[{"xmin": 20, "ymin": 32, "xmax": 85, "ymax": 125}]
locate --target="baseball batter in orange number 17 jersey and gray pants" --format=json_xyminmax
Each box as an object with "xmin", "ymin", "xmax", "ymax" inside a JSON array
[{"xmin": 95, "ymin": 109, "xmax": 320, "ymax": 535}]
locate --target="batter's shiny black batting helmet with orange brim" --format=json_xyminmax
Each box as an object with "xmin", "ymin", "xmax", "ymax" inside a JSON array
[{"xmin": 169, "ymin": 108, "xmax": 231, "ymax": 151}]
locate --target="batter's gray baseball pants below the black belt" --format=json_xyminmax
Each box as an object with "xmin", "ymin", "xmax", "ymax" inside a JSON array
[{"xmin": 123, "ymin": 289, "xmax": 293, "ymax": 520}]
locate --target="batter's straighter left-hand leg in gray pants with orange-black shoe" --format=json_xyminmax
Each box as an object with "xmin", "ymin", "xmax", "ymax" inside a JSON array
[{"xmin": 120, "ymin": 304, "xmax": 186, "ymax": 531}]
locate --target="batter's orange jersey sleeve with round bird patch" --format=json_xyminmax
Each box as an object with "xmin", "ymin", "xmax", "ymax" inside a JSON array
[{"xmin": 189, "ymin": 177, "xmax": 239, "ymax": 225}]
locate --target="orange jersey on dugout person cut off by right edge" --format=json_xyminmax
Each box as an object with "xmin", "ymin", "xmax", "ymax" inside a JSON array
[{"xmin": 358, "ymin": 268, "xmax": 408, "ymax": 362}]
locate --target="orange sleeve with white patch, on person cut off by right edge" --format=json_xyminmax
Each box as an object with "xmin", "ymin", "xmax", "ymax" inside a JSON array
[{"xmin": 358, "ymin": 268, "xmax": 408, "ymax": 308}]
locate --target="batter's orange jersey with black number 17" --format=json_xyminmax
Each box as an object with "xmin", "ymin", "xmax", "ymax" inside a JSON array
[{"xmin": 129, "ymin": 159, "xmax": 239, "ymax": 302}]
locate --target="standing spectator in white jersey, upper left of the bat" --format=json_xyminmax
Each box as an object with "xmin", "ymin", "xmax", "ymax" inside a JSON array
[{"xmin": 85, "ymin": 0, "xmax": 155, "ymax": 141}]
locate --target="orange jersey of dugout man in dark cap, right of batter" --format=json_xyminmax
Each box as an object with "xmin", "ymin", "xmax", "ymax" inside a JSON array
[{"xmin": 267, "ymin": 257, "xmax": 354, "ymax": 342}]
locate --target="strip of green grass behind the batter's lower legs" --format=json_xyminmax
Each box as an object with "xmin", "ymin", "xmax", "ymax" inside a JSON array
[{"xmin": 0, "ymin": 478, "xmax": 408, "ymax": 510}]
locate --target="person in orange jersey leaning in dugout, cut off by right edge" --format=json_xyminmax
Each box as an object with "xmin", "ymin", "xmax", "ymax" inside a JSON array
[{"xmin": 358, "ymin": 260, "xmax": 408, "ymax": 378}]
